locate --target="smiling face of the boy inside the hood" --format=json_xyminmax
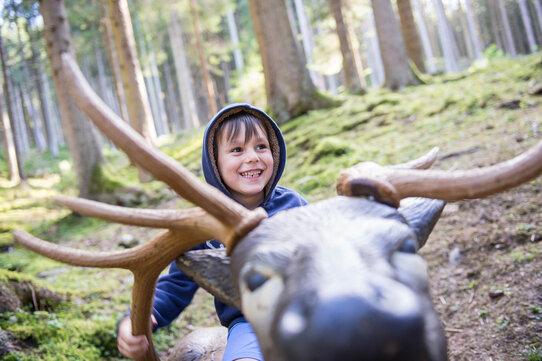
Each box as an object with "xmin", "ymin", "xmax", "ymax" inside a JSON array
[{"xmin": 217, "ymin": 124, "xmax": 273, "ymax": 209}]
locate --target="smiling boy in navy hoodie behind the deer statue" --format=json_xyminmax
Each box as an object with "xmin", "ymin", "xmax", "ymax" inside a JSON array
[{"xmin": 117, "ymin": 104, "xmax": 307, "ymax": 361}]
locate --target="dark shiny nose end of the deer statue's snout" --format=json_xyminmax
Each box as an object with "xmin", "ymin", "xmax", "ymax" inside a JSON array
[{"xmin": 275, "ymin": 281, "xmax": 429, "ymax": 361}]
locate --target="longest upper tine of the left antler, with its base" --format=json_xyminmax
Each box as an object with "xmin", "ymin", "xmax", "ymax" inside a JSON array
[{"xmin": 62, "ymin": 53, "xmax": 267, "ymax": 251}]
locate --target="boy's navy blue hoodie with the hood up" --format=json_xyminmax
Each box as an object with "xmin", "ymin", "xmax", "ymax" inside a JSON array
[{"xmin": 153, "ymin": 104, "xmax": 307, "ymax": 328}]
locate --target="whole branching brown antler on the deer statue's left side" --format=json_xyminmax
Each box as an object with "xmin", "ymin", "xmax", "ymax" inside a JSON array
[{"xmin": 13, "ymin": 53, "xmax": 267, "ymax": 361}]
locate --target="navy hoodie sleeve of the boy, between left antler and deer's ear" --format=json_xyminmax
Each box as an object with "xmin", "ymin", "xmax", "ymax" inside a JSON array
[{"xmin": 153, "ymin": 262, "xmax": 199, "ymax": 329}]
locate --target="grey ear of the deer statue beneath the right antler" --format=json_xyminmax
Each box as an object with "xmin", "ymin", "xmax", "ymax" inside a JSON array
[{"xmin": 398, "ymin": 197, "xmax": 446, "ymax": 248}]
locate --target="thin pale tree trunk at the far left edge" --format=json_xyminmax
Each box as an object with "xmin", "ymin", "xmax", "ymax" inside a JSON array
[{"xmin": 0, "ymin": 34, "xmax": 21, "ymax": 184}]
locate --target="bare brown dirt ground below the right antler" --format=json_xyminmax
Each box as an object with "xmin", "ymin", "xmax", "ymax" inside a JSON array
[{"xmin": 421, "ymin": 151, "xmax": 542, "ymax": 361}]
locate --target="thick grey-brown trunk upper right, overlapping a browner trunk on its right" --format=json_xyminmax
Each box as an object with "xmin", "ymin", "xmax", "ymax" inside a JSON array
[{"xmin": 371, "ymin": 0, "xmax": 420, "ymax": 90}]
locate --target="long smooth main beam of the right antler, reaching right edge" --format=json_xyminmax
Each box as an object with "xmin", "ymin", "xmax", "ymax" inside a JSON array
[{"xmin": 337, "ymin": 141, "xmax": 542, "ymax": 207}]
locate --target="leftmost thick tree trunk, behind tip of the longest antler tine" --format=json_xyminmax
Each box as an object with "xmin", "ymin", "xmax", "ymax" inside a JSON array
[{"xmin": 40, "ymin": 0, "xmax": 101, "ymax": 198}]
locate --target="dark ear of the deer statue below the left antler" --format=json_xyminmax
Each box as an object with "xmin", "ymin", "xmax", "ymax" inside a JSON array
[{"xmin": 175, "ymin": 248, "xmax": 241, "ymax": 310}]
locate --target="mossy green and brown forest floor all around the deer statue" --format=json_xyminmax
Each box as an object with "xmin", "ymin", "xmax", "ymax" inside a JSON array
[{"xmin": 0, "ymin": 56, "xmax": 542, "ymax": 361}]
